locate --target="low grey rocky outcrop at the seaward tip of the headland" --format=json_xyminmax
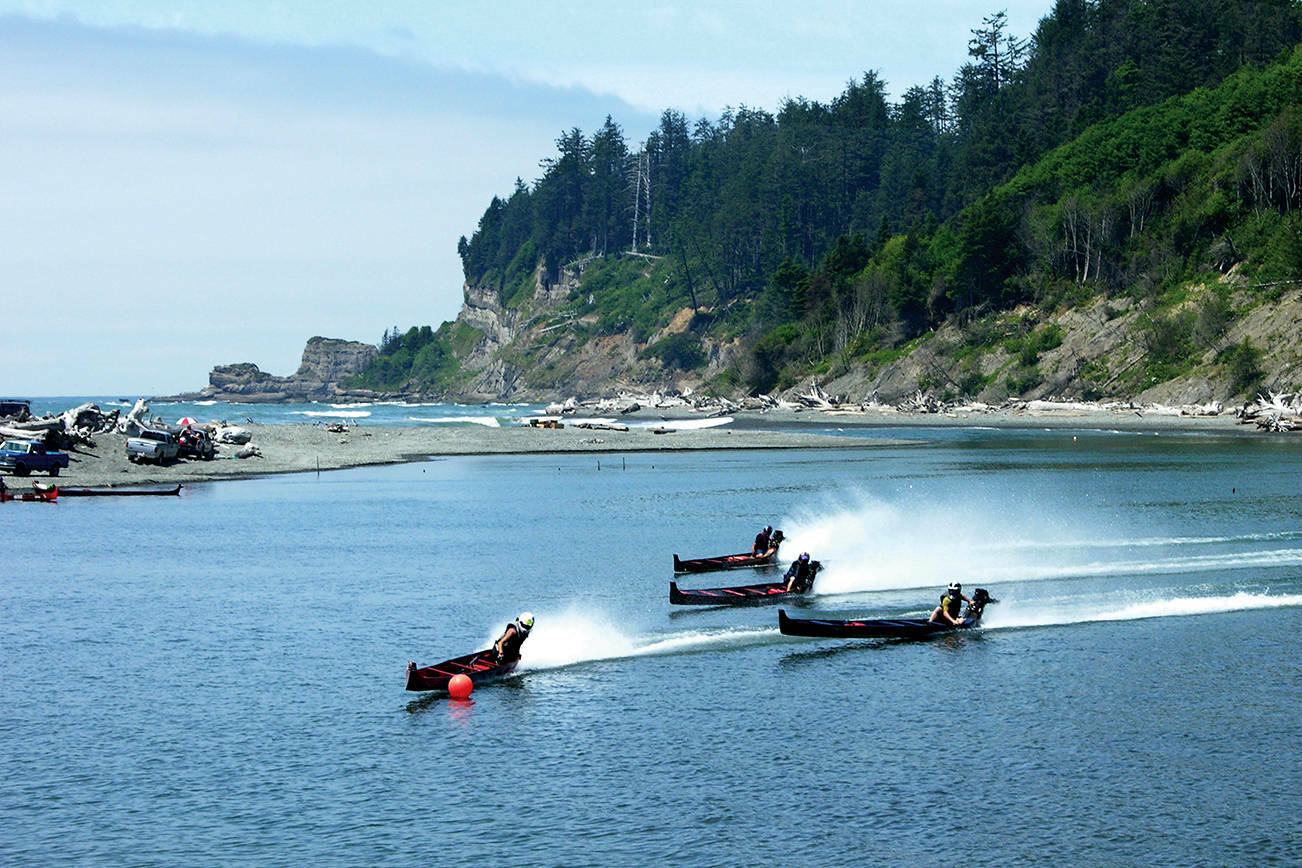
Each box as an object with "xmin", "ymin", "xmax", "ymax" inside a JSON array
[{"xmin": 186, "ymin": 337, "xmax": 379, "ymax": 403}]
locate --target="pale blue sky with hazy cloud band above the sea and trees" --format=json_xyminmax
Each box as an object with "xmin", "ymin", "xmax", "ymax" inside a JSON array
[{"xmin": 0, "ymin": 0, "xmax": 1052, "ymax": 398}]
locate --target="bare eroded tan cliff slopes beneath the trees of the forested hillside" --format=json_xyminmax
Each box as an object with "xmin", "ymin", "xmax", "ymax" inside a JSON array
[{"xmin": 445, "ymin": 257, "xmax": 1302, "ymax": 403}]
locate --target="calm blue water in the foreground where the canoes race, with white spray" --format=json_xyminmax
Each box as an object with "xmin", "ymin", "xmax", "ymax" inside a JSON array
[{"xmin": 0, "ymin": 429, "xmax": 1302, "ymax": 865}]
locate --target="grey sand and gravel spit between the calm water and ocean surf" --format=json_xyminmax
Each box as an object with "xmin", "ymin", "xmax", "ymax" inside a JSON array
[{"xmin": 4, "ymin": 407, "xmax": 1262, "ymax": 489}]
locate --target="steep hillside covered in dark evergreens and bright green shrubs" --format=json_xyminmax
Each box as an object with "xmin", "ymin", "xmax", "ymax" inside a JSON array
[{"xmin": 346, "ymin": 0, "xmax": 1302, "ymax": 397}]
